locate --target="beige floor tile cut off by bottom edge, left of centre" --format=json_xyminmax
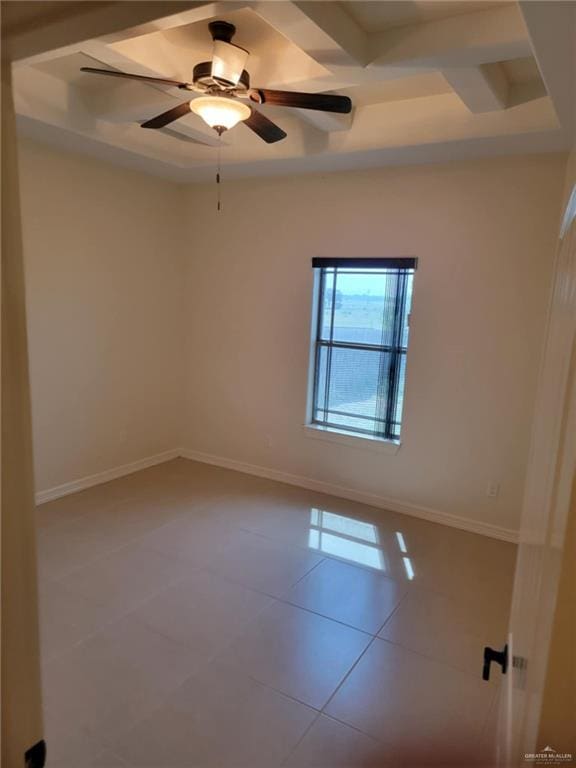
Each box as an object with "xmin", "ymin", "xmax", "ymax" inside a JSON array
[{"xmin": 115, "ymin": 663, "xmax": 316, "ymax": 768}]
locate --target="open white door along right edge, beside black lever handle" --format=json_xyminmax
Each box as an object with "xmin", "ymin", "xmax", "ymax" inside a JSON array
[{"xmin": 497, "ymin": 180, "xmax": 576, "ymax": 765}]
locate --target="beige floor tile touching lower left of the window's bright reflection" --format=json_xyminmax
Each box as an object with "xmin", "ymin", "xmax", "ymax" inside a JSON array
[{"xmin": 208, "ymin": 532, "xmax": 322, "ymax": 597}]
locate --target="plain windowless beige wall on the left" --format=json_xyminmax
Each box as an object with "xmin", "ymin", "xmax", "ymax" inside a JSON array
[{"xmin": 20, "ymin": 140, "xmax": 183, "ymax": 490}]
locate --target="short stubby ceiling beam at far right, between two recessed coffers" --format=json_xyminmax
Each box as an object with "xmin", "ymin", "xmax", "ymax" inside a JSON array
[{"xmin": 442, "ymin": 63, "xmax": 509, "ymax": 112}]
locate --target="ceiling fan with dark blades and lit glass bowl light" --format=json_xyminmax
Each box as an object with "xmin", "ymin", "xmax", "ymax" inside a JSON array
[{"xmin": 81, "ymin": 21, "xmax": 352, "ymax": 144}]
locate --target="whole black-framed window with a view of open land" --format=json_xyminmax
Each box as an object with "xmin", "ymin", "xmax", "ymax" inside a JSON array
[{"xmin": 310, "ymin": 258, "xmax": 417, "ymax": 441}]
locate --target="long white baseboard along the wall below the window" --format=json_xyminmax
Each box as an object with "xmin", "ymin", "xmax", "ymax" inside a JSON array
[{"xmin": 179, "ymin": 449, "xmax": 518, "ymax": 544}]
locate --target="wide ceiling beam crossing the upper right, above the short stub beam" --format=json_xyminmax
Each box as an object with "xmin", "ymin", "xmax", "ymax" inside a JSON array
[{"xmin": 369, "ymin": 4, "xmax": 531, "ymax": 69}]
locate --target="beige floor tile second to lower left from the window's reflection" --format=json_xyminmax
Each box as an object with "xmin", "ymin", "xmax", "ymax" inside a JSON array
[{"xmin": 134, "ymin": 570, "xmax": 273, "ymax": 659}]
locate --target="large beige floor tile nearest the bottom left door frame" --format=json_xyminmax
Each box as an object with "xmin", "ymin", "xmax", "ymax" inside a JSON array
[{"xmin": 43, "ymin": 618, "xmax": 201, "ymax": 751}]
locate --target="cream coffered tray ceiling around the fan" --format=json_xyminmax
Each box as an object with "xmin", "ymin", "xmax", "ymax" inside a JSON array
[{"xmin": 14, "ymin": 0, "xmax": 576, "ymax": 180}]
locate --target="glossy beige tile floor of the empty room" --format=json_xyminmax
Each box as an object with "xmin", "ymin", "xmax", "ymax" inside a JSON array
[{"xmin": 37, "ymin": 459, "xmax": 515, "ymax": 768}]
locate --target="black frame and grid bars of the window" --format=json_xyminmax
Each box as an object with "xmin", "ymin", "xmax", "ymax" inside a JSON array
[{"xmin": 310, "ymin": 257, "xmax": 418, "ymax": 442}]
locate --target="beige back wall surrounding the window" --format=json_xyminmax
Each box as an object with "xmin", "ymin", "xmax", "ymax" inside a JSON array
[{"xmin": 184, "ymin": 155, "xmax": 566, "ymax": 529}]
